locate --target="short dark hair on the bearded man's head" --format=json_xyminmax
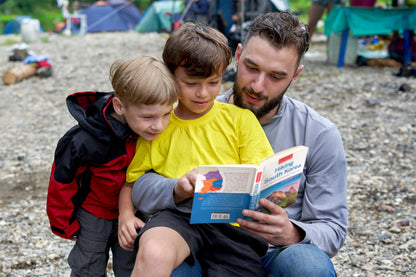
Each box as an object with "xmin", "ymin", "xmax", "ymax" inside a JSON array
[{"xmin": 244, "ymin": 12, "xmax": 310, "ymax": 64}]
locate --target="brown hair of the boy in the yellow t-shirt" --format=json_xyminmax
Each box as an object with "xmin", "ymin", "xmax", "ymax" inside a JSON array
[{"xmin": 163, "ymin": 22, "xmax": 232, "ymax": 78}]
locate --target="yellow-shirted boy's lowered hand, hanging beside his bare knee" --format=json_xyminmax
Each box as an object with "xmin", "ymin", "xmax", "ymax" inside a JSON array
[{"xmin": 118, "ymin": 213, "xmax": 144, "ymax": 251}]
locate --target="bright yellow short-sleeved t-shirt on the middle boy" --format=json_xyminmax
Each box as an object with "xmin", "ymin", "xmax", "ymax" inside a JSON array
[{"xmin": 126, "ymin": 101, "xmax": 273, "ymax": 183}]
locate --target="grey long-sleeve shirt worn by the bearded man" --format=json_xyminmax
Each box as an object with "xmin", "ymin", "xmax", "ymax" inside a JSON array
[{"xmin": 132, "ymin": 90, "xmax": 348, "ymax": 257}]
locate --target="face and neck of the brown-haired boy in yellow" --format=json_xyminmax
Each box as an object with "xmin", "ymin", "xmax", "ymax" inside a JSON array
[{"xmin": 174, "ymin": 67, "xmax": 222, "ymax": 120}]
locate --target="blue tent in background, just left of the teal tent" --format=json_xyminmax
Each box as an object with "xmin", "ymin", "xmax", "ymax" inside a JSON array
[{"xmin": 78, "ymin": 0, "xmax": 141, "ymax": 32}]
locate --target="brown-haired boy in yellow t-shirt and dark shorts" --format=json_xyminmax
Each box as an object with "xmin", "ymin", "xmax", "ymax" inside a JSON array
[{"xmin": 119, "ymin": 22, "xmax": 273, "ymax": 276}]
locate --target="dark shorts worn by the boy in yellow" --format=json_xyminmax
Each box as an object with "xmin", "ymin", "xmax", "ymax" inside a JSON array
[{"xmin": 135, "ymin": 210, "xmax": 268, "ymax": 277}]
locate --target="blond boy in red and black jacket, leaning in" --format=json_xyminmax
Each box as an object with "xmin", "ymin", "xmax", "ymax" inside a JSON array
[{"xmin": 46, "ymin": 56, "xmax": 178, "ymax": 277}]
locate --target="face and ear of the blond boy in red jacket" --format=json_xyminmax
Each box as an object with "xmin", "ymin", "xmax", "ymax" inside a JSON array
[{"xmin": 113, "ymin": 98, "xmax": 173, "ymax": 140}]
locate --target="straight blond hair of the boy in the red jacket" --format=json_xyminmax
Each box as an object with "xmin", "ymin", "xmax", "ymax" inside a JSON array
[{"xmin": 110, "ymin": 55, "xmax": 179, "ymax": 105}]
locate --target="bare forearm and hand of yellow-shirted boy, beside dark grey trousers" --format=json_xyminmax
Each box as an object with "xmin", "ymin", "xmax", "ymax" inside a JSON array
[{"xmin": 118, "ymin": 183, "xmax": 144, "ymax": 251}]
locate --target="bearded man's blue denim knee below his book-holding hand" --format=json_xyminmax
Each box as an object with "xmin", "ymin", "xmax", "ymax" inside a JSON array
[{"xmin": 265, "ymin": 244, "xmax": 336, "ymax": 277}]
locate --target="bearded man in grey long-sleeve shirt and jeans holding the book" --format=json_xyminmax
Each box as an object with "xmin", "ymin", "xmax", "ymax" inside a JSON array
[{"xmin": 133, "ymin": 12, "xmax": 348, "ymax": 276}]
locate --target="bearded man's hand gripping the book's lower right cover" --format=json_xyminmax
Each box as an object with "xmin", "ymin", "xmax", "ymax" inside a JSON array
[{"xmin": 237, "ymin": 199, "xmax": 305, "ymax": 246}]
